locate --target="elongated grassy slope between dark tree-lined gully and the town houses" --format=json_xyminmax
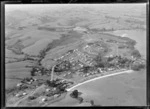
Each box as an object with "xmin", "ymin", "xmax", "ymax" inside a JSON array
[{"xmin": 42, "ymin": 32, "xmax": 82, "ymax": 67}]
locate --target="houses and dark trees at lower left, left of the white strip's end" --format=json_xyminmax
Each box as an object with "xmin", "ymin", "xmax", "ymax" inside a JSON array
[{"xmin": 6, "ymin": 77, "xmax": 73, "ymax": 104}]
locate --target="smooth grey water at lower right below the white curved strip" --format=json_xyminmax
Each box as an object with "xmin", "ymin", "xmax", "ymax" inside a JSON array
[{"xmin": 51, "ymin": 70, "xmax": 146, "ymax": 106}]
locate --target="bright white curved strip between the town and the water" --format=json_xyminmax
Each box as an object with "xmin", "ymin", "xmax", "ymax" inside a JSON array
[{"xmin": 67, "ymin": 70, "xmax": 133, "ymax": 91}]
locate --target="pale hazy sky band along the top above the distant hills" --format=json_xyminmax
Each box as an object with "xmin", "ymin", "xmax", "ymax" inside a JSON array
[{"xmin": 5, "ymin": 3, "xmax": 146, "ymax": 11}]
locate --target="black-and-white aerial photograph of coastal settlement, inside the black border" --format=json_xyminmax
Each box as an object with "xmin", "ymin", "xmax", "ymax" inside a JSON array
[{"xmin": 5, "ymin": 3, "xmax": 147, "ymax": 107}]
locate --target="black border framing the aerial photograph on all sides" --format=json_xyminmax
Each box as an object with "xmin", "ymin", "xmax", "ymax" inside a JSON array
[{"xmin": 1, "ymin": 0, "xmax": 150, "ymax": 109}]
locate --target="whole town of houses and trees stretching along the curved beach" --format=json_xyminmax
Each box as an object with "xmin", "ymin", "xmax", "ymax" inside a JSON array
[{"xmin": 6, "ymin": 36, "xmax": 145, "ymax": 106}]
